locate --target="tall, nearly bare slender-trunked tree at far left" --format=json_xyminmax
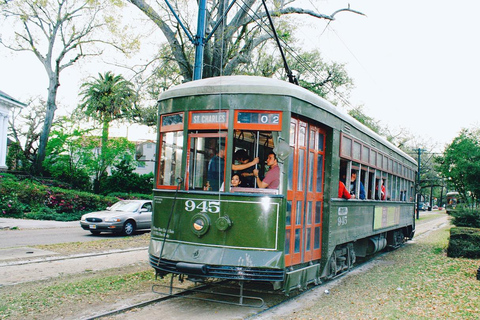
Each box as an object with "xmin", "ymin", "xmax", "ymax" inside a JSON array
[{"xmin": 0, "ymin": 0, "xmax": 137, "ymax": 172}]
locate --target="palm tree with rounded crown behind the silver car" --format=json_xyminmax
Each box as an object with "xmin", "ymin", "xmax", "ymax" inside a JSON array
[{"xmin": 79, "ymin": 71, "xmax": 136, "ymax": 192}]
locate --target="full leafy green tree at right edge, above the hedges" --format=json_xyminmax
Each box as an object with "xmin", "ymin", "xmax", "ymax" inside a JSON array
[{"xmin": 436, "ymin": 129, "xmax": 480, "ymax": 203}]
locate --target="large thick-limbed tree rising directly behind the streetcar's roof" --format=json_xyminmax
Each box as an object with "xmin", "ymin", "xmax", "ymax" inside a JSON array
[{"xmin": 128, "ymin": 0, "xmax": 359, "ymax": 85}]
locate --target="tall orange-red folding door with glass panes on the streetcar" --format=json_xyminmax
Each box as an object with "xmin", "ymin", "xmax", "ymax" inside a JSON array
[{"xmin": 285, "ymin": 119, "xmax": 326, "ymax": 266}]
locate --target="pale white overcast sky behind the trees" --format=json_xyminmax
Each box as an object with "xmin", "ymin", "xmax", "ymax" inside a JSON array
[{"xmin": 0, "ymin": 0, "xmax": 480, "ymax": 151}]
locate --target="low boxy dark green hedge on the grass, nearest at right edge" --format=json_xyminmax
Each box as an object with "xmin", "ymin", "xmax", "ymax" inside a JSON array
[{"xmin": 447, "ymin": 227, "xmax": 480, "ymax": 259}]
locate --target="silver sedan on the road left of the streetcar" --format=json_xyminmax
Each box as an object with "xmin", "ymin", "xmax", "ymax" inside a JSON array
[{"xmin": 80, "ymin": 200, "xmax": 152, "ymax": 236}]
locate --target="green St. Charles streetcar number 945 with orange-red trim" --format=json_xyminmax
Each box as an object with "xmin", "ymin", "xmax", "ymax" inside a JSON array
[{"xmin": 149, "ymin": 76, "xmax": 417, "ymax": 294}]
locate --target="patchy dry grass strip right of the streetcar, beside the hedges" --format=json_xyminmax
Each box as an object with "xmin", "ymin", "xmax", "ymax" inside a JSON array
[{"xmin": 284, "ymin": 229, "xmax": 480, "ymax": 319}]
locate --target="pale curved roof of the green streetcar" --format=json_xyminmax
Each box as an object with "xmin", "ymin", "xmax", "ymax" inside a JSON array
[{"xmin": 159, "ymin": 76, "xmax": 416, "ymax": 164}]
